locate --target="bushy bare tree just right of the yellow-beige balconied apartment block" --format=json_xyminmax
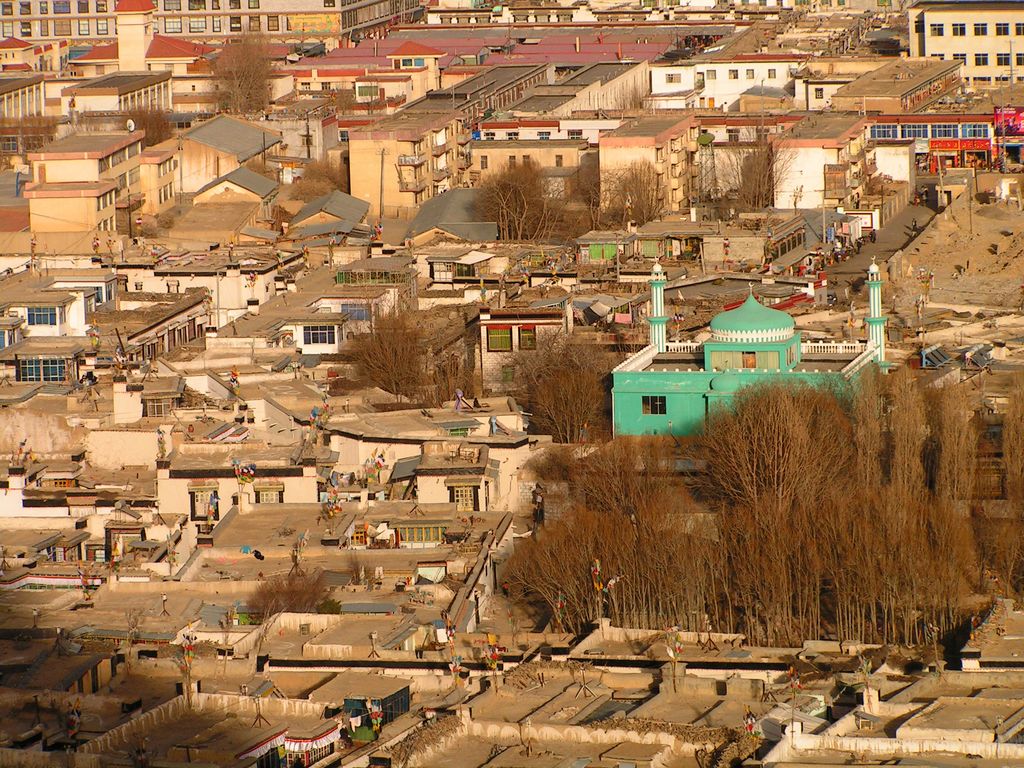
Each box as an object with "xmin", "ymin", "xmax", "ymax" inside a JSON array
[{"xmin": 476, "ymin": 163, "xmax": 558, "ymax": 241}]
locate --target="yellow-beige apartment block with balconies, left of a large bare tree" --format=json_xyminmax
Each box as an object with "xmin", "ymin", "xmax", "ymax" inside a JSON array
[{"xmin": 348, "ymin": 112, "xmax": 471, "ymax": 218}]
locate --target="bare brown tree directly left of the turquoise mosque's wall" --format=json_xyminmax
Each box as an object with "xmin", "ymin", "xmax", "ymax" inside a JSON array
[{"xmin": 513, "ymin": 336, "xmax": 611, "ymax": 442}]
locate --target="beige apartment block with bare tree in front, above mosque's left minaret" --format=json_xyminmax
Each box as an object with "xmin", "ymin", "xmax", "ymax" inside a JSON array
[{"xmin": 599, "ymin": 116, "xmax": 700, "ymax": 219}]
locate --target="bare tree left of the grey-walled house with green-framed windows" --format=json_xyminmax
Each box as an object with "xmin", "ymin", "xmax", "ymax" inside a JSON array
[{"xmin": 353, "ymin": 311, "xmax": 426, "ymax": 399}]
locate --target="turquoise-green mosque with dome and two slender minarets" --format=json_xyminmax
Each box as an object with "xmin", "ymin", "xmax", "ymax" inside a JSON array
[{"xmin": 611, "ymin": 264, "xmax": 886, "ymax": 435}]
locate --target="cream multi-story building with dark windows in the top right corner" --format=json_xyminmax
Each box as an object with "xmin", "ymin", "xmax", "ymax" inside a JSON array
[{"xmin": 907, "ymin": 0, "xmax": 1024, "ymax": 87}]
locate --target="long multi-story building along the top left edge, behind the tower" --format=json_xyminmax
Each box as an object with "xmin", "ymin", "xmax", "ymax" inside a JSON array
[{"xmin": 0, "ymin": 0, "xmax": 419, "ymax": 43}]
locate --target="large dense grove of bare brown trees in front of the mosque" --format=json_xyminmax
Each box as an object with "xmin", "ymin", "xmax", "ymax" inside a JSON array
[{"xmin": 508, "ymin": 373, "xmax": 1007, "ymax": 645}]
